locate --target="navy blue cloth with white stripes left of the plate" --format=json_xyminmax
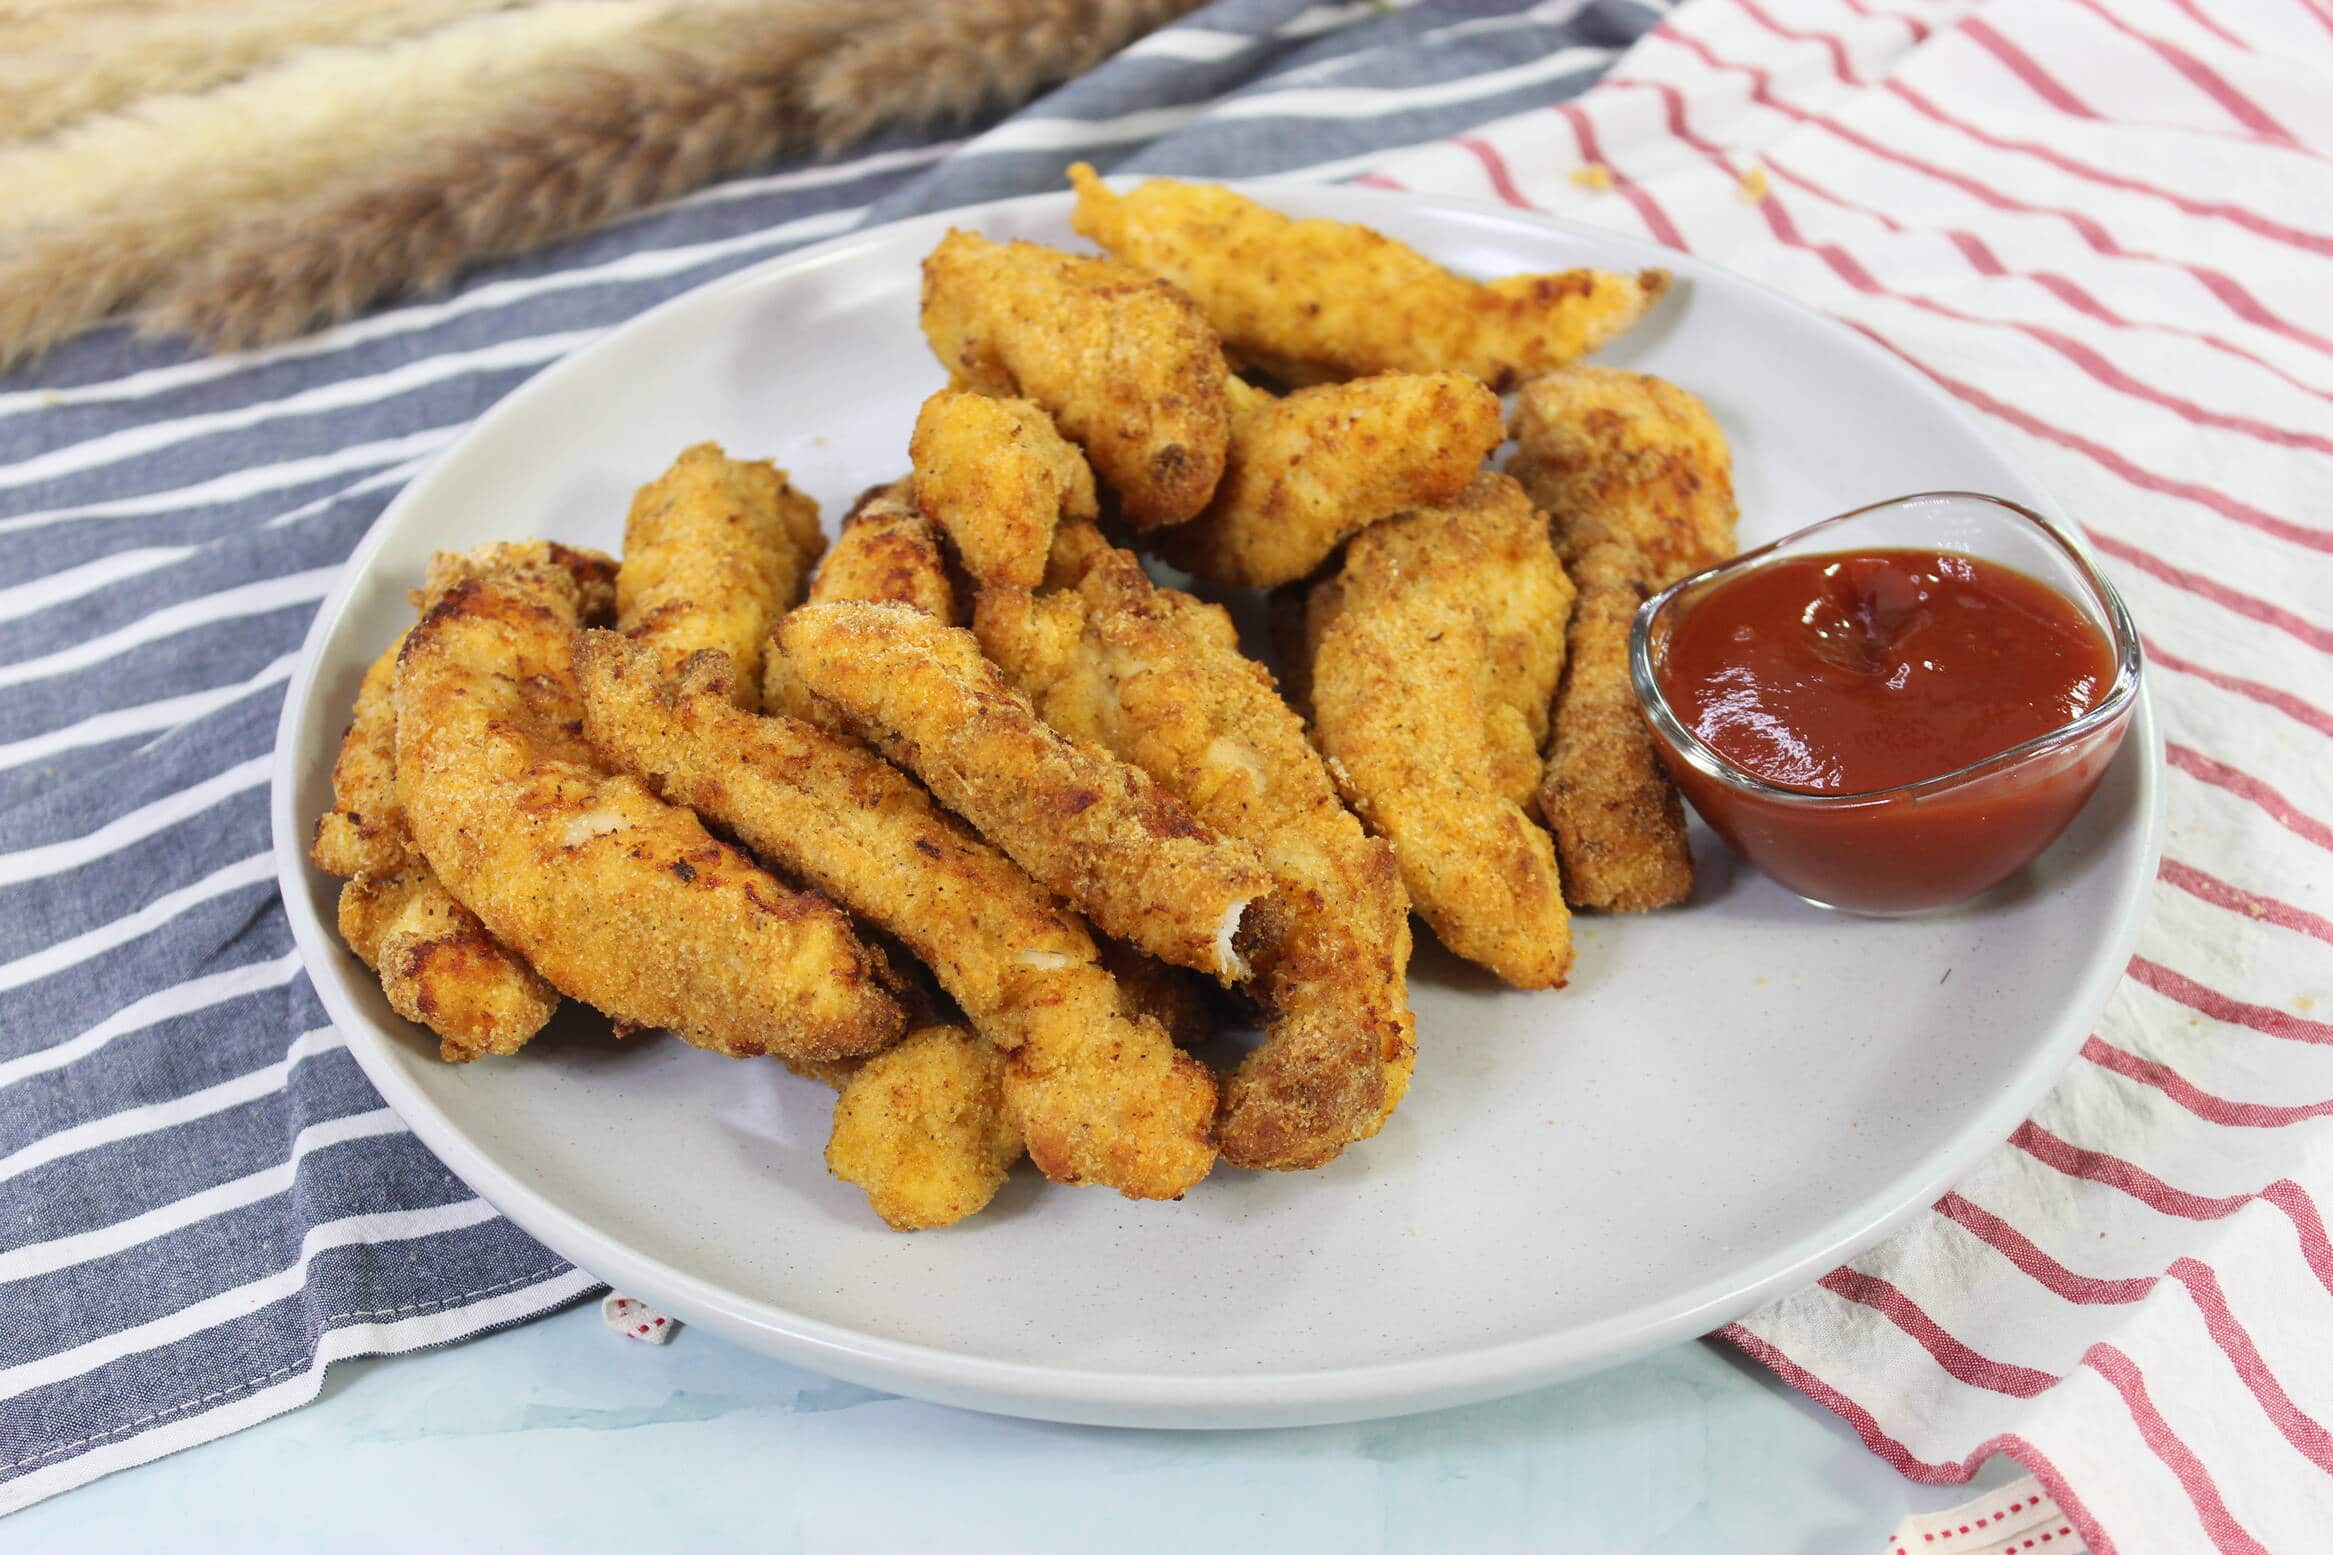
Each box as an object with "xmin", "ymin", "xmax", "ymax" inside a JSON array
[{"xmin": 0, "ymin": 0, "xmax": 1654, "ymax": 1511}]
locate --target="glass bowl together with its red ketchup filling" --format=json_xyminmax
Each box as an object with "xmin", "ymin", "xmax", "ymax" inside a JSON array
[{"xmin": 1628, "ymin": 492, "xmax": 2139, "ymax": 916}]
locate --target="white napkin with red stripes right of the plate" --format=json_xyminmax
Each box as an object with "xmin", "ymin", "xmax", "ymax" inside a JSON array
[{"xmin": 1362, "ymin": 0, "xmax": 2333, "ymax": 1555}]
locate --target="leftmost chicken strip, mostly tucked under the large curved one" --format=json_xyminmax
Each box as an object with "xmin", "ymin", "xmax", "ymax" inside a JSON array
[{"xmin": 310, "ymin": 634, "xmax": 560, "ymax": 1063}]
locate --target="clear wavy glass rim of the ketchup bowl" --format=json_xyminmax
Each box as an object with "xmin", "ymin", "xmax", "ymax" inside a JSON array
[{"xmin": 1628, "ymin": 490, "xmax": 2144, "ymax": 809}]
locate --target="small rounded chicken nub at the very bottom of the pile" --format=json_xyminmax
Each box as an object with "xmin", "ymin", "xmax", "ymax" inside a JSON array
[{"xmin": 826, "ymin": 1026, "xmax": 1022, "ymax": 1231}]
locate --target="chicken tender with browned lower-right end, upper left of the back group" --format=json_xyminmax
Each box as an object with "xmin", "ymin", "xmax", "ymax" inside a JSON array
[{"xmin": 924, "ymin": 231, "xmax": 1229, "ymax": 529}]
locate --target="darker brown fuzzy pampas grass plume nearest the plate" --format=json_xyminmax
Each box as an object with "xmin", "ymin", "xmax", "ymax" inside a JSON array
[{"xmin": 141, "ymin": 0, "xmax": 1197, "ymax": 350}]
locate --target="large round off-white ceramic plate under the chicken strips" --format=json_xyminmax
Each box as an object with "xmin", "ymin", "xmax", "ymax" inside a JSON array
[{"xmin": 273, "ymin": 187, "xmax": 2160, "ymax": 1427}]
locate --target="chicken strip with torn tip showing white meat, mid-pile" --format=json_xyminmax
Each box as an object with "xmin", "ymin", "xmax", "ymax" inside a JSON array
[{"xmin": 779, "ymin": 604, "xmax": 1271, "ymax": 981}]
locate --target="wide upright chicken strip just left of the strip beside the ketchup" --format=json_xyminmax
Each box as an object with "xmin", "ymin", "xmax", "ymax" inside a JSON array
[{"xmin": 1306, "ymin": 476, "xmax": 1572, "ymax": 988}]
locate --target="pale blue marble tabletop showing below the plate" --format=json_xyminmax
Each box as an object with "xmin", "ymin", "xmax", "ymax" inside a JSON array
[{"xmin": 0, "ymin": 1301, "xmax": 2013, "ymax": 1555}]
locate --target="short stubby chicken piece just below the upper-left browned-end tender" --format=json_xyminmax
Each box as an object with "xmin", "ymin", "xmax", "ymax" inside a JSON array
[{"xmin": 908, "ymin": 389, "xmax": 1099, "ymax": 587}]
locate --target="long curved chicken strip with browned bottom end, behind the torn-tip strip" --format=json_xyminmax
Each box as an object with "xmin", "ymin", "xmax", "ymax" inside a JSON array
[{"xmin": 973, "ymin": 548, "xmax": 1416, "ymax": 1170}]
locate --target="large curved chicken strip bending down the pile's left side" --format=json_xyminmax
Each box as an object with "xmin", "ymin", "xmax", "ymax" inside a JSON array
[{"xmin": 397, "ymin": 547, "xmax": 905, "ymax": 1058}]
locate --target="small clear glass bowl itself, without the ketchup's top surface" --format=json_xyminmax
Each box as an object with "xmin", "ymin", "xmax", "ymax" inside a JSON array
[{"xmin": 1628, "ymin": 492, "xmax": 2139, "ymax": 916}]
